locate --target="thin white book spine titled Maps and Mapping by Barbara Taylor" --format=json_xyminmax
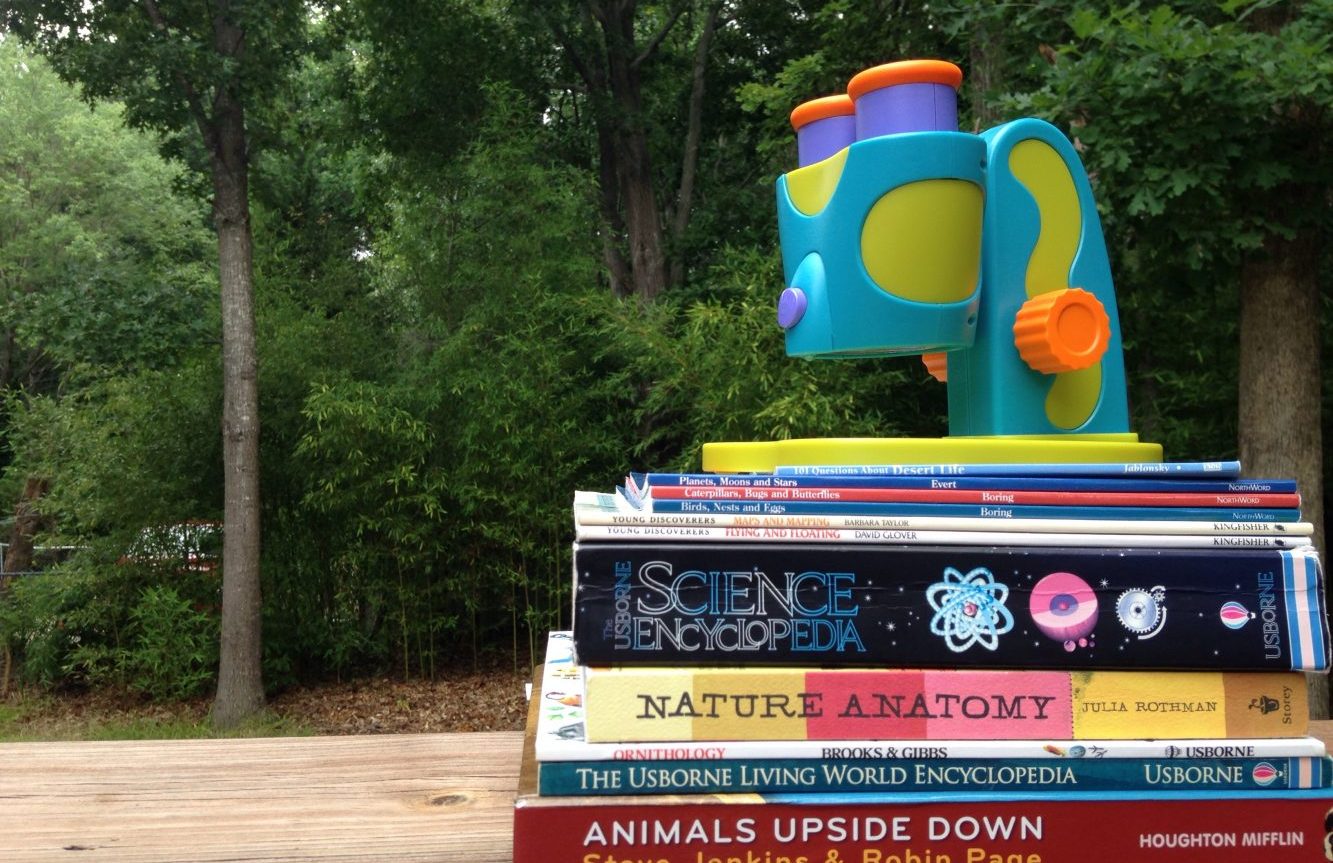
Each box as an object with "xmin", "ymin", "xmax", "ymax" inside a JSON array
[{"xmin": 575, "ymin": 506, "xmax": 1314, "ymax": 536}]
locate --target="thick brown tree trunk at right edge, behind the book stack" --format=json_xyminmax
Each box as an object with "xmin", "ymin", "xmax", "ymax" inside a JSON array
[{"xmin": 1238, "ymin": 229, "xmax": 1329, "ymax": 719}]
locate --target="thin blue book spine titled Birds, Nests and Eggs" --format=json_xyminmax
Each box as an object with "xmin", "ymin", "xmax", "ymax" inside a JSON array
[{"xmin": 645, "ymin": 498, "xmax": 1301, "ymax": 522}]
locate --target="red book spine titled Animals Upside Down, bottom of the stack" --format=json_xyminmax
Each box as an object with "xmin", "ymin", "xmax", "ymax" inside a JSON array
[{"xmin": 513, "ymin": 790, "xmax": 1333, "ymax": 863}]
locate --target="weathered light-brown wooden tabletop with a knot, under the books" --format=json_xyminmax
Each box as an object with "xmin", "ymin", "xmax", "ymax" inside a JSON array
[{"xmin": 0, "ymin": 722, "xmax": 1333, "ymax": 863}]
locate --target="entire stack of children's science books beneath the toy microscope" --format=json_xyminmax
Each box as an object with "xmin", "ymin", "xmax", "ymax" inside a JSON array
[{"xmin": 515, "ymin": 463, "xmax": 1333, "ymax": 863}]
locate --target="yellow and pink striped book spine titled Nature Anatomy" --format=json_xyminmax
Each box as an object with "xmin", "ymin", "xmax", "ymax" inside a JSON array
[{"xmin": 584, "ymin": 667, "xmax": 1308, "ymax": 743}]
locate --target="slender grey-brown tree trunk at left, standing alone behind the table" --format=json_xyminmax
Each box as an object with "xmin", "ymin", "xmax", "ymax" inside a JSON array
[{"xmin": 209, "ymin": 77, "xmax": 264, "ymax": 728}]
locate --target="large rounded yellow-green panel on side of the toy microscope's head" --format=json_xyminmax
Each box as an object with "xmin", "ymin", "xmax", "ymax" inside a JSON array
[{"xmin": 861, "ymin": 180, "xmax": 982, "ymax": 303}]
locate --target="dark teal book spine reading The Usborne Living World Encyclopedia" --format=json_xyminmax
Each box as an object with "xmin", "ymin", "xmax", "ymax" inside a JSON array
[{"xmin": 539, "ymin": 758, "xmax": 1326, "ymax": 796}]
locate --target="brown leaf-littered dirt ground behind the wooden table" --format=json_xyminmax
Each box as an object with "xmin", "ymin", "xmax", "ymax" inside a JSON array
[{"xmin": 0, "ymin": 670, "xmax": 528, "ymax": 739}]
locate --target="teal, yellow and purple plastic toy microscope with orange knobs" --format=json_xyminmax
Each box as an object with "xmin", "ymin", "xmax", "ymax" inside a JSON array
[{"xmin": 704, "ymin": 60, "xmax": 1162, "ymax": 472}]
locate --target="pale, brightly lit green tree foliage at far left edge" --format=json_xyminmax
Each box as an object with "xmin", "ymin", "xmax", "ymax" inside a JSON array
[{"xmin": 0, "ymin": 39, "xmax": 216, "ymax": 392}]
